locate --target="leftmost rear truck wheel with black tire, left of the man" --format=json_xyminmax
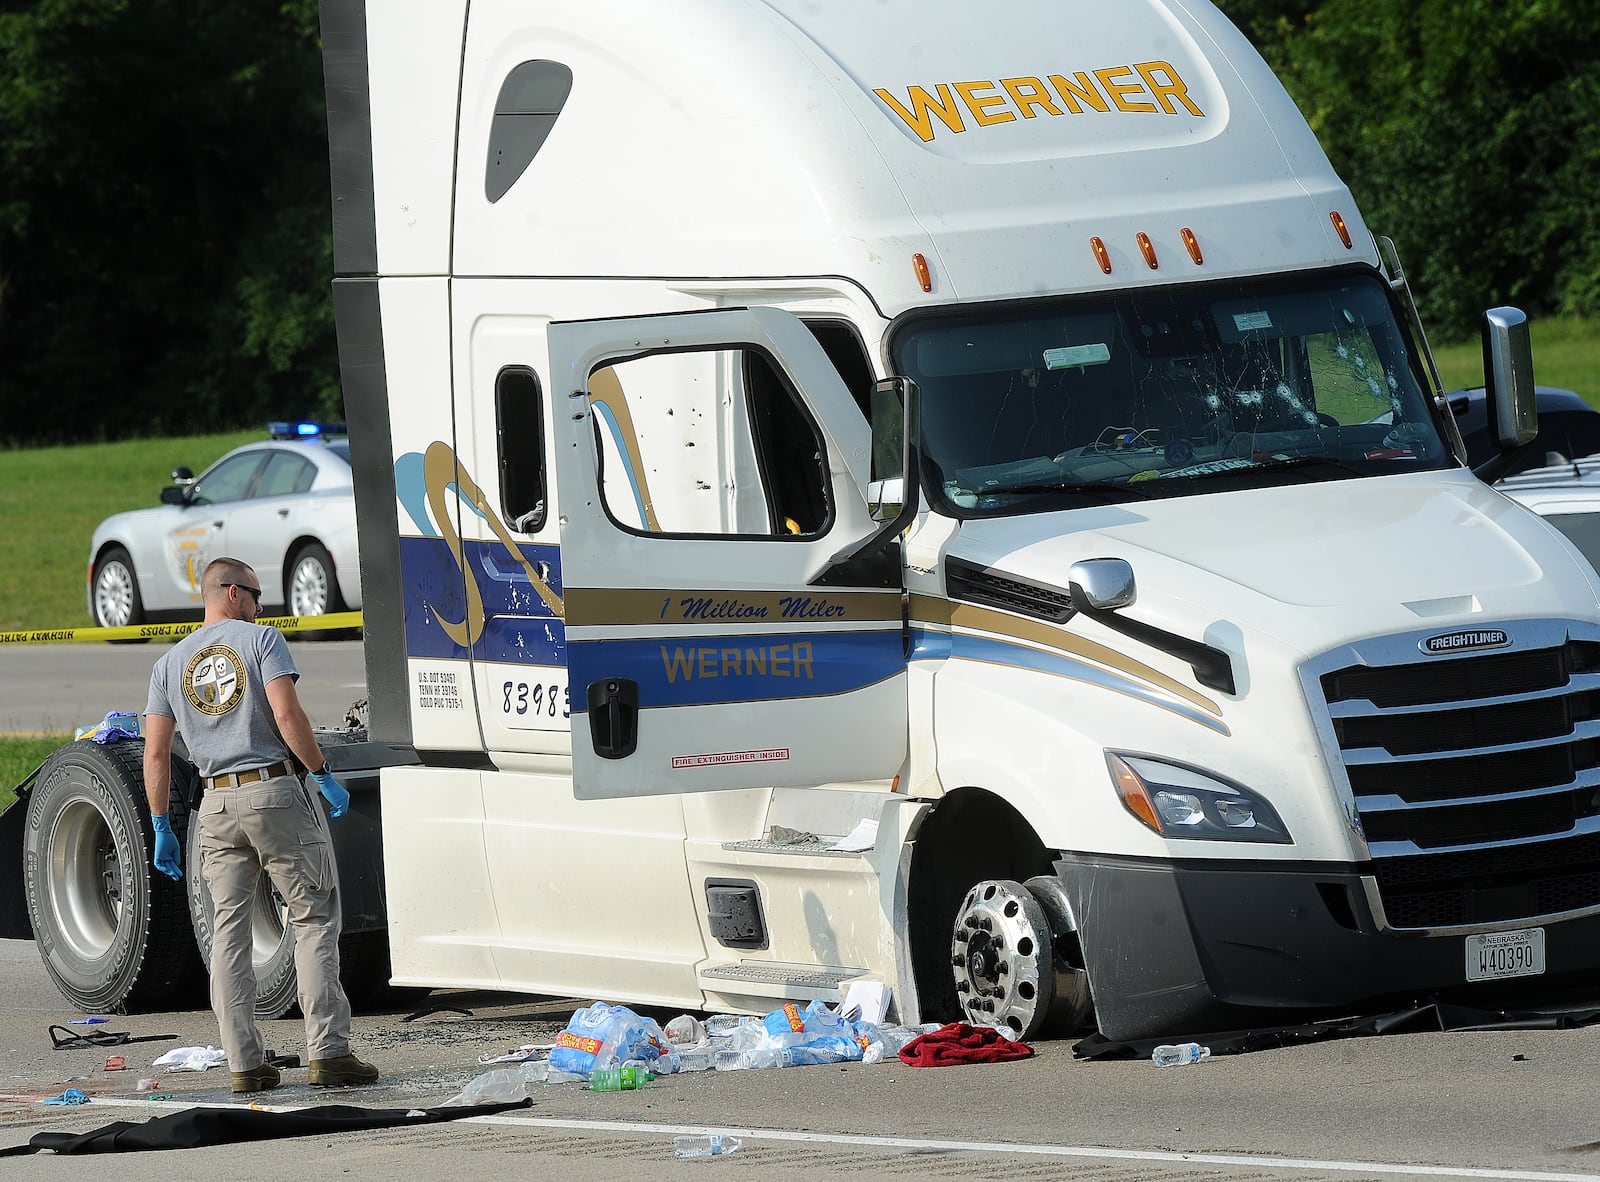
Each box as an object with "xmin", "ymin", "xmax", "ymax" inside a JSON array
[{"xmin": 22, "ymin": 739, "xmax": 198, "ymax": 1014}]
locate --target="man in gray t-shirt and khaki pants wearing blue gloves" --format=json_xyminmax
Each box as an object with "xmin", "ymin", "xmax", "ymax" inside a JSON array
[{"xmin": 144, "ymin": 558, "xmax": 378, "ymax": 1092}]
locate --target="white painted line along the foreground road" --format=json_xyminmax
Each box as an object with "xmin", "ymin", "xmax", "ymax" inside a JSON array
[{"xmin": 72, "ymin": 1097, "xmax": 1600, "ymax": 1182}]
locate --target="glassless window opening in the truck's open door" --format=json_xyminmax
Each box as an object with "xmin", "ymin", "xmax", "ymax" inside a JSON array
[{"xmin": 589, "ymin": 349, "xmax": 832, "ymax": 537}]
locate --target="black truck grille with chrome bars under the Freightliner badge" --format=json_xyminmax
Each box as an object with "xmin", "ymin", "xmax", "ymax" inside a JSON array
[{"xmin": 1322, "ymin": 640, "xmax": 1600, "ymax": 928}]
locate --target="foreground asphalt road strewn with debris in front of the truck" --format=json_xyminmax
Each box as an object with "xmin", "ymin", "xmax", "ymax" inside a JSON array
[{"xmin": 0, "ymin": 940, "xmax": 1600, "ymax": 1182}]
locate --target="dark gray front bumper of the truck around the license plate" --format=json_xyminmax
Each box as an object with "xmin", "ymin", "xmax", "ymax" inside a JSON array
[{"xmin": 1056, "ymin": 854, "xmax": 1600, "ymax": 1040}]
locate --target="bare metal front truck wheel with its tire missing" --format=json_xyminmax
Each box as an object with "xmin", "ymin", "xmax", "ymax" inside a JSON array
[{"xmin": 950, "ymin": 878, "xmax": 1090, "ymax": 1038}]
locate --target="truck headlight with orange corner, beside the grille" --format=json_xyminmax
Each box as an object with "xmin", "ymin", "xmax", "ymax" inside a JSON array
[{"xmin": 1106, "ymin": 752, "xmax": 1293, "ymax": 845}]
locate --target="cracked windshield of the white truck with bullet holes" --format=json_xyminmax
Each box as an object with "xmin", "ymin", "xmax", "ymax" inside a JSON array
[{"xmin": 894, "ymin": 277, "xmax": 1454, "ymax": 517}]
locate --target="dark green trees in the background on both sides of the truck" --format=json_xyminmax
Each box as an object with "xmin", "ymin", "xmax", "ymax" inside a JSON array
[{"xmin": 0, "ymin": 0, "xmax": 1600, "ymax": 445}]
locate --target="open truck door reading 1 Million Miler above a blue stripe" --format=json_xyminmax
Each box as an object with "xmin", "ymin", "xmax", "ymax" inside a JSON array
[{"xmin": 549, "ymin": 309, "xmax": 907, "ymax": 798}]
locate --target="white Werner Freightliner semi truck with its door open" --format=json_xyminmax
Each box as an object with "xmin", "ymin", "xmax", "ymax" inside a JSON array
[{"xmin": 6, "ymin": 0, "xmax": 1600, "ymax": 1038}]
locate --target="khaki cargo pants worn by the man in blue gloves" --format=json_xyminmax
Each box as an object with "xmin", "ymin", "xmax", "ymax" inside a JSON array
[{"xmin": 200, "ymin": 776, "xmax": 350, "ymax": 1072}]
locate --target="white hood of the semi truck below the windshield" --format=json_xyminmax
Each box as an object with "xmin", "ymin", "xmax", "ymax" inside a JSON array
[{"xmin": 949, "ymin": 472, "xmax": 1600, "ymax": 651}]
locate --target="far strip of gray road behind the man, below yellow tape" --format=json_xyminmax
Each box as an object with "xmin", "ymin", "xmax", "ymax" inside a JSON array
[{"xmin": 0, "ymin": 633, "xmax": 366, "ymax": 734}]
